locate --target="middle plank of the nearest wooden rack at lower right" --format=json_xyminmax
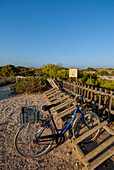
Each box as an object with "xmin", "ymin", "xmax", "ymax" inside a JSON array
[{"xmin": 82, "ymin": 136, "xmax": 114, "ymax": 164}]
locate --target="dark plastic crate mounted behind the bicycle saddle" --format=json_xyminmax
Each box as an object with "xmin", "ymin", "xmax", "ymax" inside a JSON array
[{"xmin": 20, "ymin": 105, "xmax": 40, "ymax": 124}]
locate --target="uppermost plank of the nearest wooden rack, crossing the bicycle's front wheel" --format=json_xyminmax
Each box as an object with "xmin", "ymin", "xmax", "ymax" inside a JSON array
[{"xmin": 74, "ymin": 121, "xmax": 108, "ymax": 145}]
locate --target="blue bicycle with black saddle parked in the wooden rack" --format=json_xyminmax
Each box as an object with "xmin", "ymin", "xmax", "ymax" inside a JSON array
[{"xmin": 14, "ymin": 94, "xmax": 100, "ymax": 158}]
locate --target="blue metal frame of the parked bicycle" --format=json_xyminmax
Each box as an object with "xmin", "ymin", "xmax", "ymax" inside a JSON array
[{"xmin": 35, "ymin": 105, "xmax": 88, "ymax": 143}]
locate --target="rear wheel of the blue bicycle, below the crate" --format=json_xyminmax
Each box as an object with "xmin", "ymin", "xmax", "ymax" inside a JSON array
[{"xmin": 14, "ymin": 123, "xmax": 54, "ymax": 158}]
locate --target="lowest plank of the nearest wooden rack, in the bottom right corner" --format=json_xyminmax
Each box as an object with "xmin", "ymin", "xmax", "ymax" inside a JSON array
[{"xmin": 87, "ymin": 146, "xmax": 114, "ymax": 170}]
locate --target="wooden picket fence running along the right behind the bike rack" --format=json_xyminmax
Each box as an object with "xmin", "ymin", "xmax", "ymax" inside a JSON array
[{"xmin": 56, "ymin": 79, "xmax": 114, "ymax": 115}]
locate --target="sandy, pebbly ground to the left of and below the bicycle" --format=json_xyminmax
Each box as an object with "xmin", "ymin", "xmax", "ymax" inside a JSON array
[{"xmin": 0, "ymin": 86, "xmax": 80, "ymax": 170}]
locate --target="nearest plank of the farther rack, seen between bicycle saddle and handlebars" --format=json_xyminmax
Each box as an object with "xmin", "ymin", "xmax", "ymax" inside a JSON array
[{"xmin": 57, "ymin": 106, "xmax": 76, "ymax": 118}]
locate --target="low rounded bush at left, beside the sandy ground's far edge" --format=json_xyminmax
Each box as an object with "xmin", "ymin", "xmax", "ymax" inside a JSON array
[{"xmin": 10, "ymin": 76, "xmax": 47, "ymax": 93}]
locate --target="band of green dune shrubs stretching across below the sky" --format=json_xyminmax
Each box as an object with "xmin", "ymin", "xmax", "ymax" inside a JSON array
[{"xmin": 0, "ymin": 64, "xmax": 114, "ymax": 93}]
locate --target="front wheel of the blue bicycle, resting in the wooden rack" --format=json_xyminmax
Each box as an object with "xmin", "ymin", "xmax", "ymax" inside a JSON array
[{"xmin": 72, "ymin": 111, "xmax": 100, "ymax": 143}]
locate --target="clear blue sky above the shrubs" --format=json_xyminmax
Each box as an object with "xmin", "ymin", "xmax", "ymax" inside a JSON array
[{"xmin": 0, "ymin": 0, "xmax": 114, "ymax": 68}]
